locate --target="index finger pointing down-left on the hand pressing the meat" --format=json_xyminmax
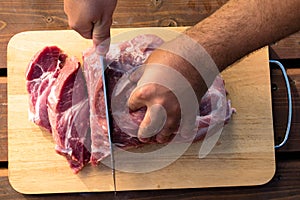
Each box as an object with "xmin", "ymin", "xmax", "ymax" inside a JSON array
[{"xmin": 138, "ymin": 104, "xmax": 167, "ymax": 141}]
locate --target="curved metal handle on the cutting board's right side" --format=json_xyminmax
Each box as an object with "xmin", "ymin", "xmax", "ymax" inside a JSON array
[{"xmin": 269, "ymin": 60, "xmax": 293, "ymax": 149}]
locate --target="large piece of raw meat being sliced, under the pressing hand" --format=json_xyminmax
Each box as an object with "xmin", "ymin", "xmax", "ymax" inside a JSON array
[{"xmin": 84, "ymin": 35, "xmax": 234, "ymax": 164}]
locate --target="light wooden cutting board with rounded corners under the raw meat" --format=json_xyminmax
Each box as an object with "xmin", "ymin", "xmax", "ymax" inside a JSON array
[{"xmin": 7, "ymin": 28, "xmax": 275, "ymax": 194}]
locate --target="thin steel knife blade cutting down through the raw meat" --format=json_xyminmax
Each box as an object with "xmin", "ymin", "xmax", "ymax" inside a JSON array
[{"xmin": 100, "ymin": 55, "xmax": 117, "ymax": 194}]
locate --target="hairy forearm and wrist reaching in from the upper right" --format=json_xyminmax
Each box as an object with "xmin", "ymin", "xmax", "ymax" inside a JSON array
[{"xmin": 142, "ymin": 0, "xmax": 300, "ymax": 105}]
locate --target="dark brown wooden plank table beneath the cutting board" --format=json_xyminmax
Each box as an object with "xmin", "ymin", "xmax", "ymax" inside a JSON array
[{"xmin": 0, "ymin": 0, "xmax": 300, "ymax": 199}]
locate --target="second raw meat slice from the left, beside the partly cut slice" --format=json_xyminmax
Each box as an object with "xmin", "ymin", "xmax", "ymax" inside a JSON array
[{"xmin": 47, "ymin": 57, "xmax": 91, "ymax": 173}]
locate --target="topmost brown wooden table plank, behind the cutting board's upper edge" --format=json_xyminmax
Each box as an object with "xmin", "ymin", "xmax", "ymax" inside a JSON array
[{"xmin": 0, "ymin": 0, "xmax": 300, "ymax": 68}]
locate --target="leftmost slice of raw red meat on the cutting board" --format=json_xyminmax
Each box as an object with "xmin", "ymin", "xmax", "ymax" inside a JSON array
[{"xmin": 26, "ymin": 46, "xmax": 66, "ymax": 132}]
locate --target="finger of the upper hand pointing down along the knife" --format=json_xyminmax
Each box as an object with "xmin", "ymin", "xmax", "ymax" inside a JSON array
[{"xmin": 92, "ymin": 19, "xmax": 112, "ymax": 55}]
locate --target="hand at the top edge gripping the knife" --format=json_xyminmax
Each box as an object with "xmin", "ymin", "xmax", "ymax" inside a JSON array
[{"xmin": 64, "ymin": 0, "xmax": 117, "ymax": 54}]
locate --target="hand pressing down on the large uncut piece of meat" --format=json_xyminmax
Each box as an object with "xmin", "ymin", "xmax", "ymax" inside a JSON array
[{"xmin": 128, "ymin": 49, "xmax": 207, "ymax": 143}]
